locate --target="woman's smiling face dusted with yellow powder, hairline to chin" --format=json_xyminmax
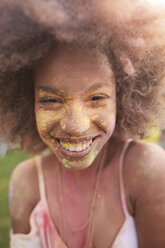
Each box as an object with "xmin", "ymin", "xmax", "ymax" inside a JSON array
[{"xmin": 34, "ymin": 43, "xmax": 116, "ymax": 169}]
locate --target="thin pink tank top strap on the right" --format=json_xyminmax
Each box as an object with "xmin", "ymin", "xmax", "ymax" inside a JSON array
[{"xmin": 119, "ymin": 139, "xmax": 132, "ymax": 216}]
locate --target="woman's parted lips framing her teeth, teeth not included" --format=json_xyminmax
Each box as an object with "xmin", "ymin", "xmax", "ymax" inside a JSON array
[{"xmin": 55, "ymin": 135, "xmax": 100, "ymax": 158}]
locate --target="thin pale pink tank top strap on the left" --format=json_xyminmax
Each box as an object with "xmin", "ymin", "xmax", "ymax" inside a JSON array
[{"xmin": 34, "ymin": 156, "xmax": 46, "ymax": 201}]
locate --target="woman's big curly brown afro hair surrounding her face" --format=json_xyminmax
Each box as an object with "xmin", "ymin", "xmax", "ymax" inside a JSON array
[{"xmin": 0, "ymin": 0, "xmax": 165, "ymax": 153}]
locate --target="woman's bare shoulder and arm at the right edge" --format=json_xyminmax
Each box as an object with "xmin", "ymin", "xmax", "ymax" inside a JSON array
[{"xmin": 124, "ymin": 143, "xmax": 165, "ymax": 248}]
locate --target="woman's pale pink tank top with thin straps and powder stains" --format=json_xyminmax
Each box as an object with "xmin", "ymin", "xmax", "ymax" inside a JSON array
[{"xmin": 10, "ymin": 140, "xmax": 138, "ymax": 248}]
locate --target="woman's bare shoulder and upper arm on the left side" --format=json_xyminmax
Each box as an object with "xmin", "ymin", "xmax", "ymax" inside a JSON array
[{"xmin": 9, "ymin": 159, "xmax": 39, "ymax": 233}]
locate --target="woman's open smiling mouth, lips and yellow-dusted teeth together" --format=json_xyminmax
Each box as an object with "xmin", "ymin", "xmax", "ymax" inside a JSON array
[{"xmin": 55, "ymin": 135, "xmax": 100, "ymax": 158}]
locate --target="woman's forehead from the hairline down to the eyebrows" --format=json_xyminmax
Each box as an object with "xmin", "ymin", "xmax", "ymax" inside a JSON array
[{"xmin": 35, "ymin": 46, "xmax": 113, "ymax": 91}]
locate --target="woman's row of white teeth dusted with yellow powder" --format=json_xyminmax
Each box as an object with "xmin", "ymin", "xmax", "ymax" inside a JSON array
[{"xmin": 60, "ymin": 140, "xmax": 92, "ymax": 152}]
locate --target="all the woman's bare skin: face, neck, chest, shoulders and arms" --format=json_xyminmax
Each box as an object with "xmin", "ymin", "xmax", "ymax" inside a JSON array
[{"xmin": 10, "ymin": 45, "xmax": 165, "ymax": 248}]
